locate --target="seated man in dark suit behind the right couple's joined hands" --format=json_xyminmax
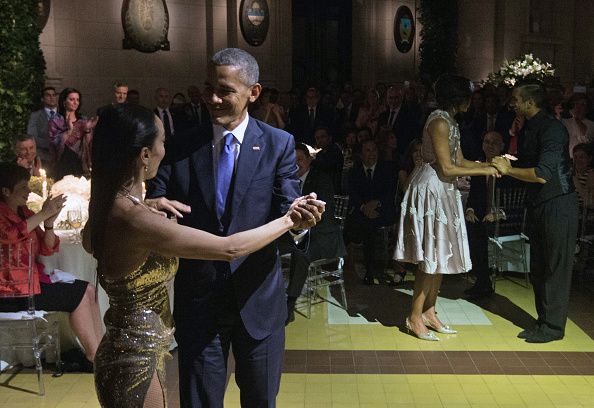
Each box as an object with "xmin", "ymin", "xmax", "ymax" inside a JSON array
[{"xmin": 464, "ymin": 131, "xmax": 514, "ymax": 299}]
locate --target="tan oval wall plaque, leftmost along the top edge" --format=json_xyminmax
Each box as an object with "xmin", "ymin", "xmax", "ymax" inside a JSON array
[{"xmin": 122, "ymin": 0, "xmax": 169, "ymax": 52}]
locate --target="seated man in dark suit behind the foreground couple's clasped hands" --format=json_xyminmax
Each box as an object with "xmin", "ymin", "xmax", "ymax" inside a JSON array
[{"xmin": 285, "ymin": 143, "xmax": 346, "ymax": 325}]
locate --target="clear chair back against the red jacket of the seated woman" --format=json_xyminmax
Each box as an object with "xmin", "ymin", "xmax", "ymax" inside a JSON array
[{"xmin": 0, "ymin": 238, "xmax": 34, "ymax": 314}]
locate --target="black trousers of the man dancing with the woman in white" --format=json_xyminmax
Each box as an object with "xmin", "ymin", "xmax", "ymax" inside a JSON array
[{"xmin": 527, "ymin": 193, "xmax": 578, "ymax": 335}]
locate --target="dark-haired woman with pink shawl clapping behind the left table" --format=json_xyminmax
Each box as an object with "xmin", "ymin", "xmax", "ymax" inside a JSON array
[{"xmin": 49, "ymin": 88, "xmax": 97, "ymax": 180}]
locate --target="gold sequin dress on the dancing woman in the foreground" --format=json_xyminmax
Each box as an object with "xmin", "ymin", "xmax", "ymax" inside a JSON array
[{"xmin": 95, "ymin": 254, "xmax": 177, "ymax": 408}]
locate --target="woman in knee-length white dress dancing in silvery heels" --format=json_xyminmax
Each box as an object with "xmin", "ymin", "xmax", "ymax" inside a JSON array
[{"xmin": 394, "ymin": 75, "xmax": 497, "ymax": 341}]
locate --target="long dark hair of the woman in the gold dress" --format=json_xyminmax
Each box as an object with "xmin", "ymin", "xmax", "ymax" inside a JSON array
[{"xmin": 89, "ymin": 104, "xmax": 158, "ymax": 260}]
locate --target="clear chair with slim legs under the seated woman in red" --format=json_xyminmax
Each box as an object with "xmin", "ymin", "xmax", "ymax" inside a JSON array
[{"xmin": 0, "ymin": 239, "xmax": 61, "ymax": 396}]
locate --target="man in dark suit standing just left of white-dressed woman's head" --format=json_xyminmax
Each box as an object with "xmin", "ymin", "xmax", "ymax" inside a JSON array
[{"xmin": 377, "ymin": 84, "xmax": 419, "ymax": 156}]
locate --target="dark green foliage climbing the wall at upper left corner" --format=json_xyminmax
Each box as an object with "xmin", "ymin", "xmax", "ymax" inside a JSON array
[{"xmin": 0, "ymin": 0, "xmax": 45, "ymax": 160}]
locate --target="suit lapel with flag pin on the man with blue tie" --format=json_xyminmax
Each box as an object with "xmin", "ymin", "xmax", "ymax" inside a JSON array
[{"xmin": 231, "ymin": 117, "xmax": 266, "ymax": 222}]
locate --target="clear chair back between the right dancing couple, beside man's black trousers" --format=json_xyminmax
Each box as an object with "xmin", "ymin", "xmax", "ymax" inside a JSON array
[{"xmin": 494, "ymin": 187, "xmax": 526, "ymax": 237}]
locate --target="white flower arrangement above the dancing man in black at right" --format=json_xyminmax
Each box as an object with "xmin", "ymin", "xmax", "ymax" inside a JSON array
[{"xmin": 485, "ymin": 54, "xmax": 555, "ymax": 88}]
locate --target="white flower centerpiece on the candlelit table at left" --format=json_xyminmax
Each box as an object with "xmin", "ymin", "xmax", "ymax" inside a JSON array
[{"xmin": 27, "ymin": 176, "xmax": 91, "ymax": 229}]
